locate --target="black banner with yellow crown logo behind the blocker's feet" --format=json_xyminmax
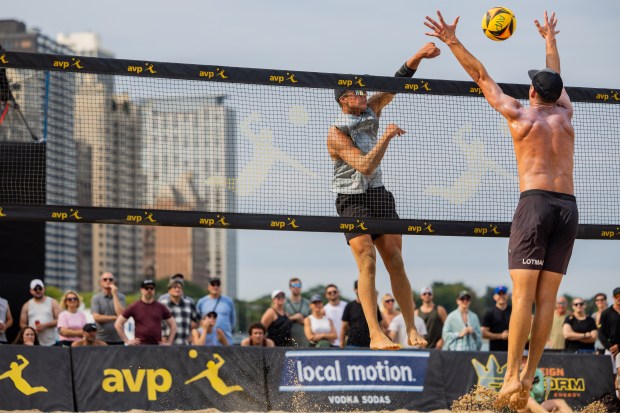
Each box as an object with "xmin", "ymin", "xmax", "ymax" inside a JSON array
[{"xmin": 441, "ymin": 351, "xmax": 614, "ymax": 409}]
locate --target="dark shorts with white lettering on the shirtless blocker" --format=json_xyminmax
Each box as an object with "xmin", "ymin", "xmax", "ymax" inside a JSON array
[{"xmin": 508, "ymin": 189, "xmax": 579, "ymax": 274}]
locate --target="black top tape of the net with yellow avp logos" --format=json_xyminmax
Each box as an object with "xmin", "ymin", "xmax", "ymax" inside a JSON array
[{"xmin": 0, "ymin": 52, "xmax": 620, "ymax": 104}]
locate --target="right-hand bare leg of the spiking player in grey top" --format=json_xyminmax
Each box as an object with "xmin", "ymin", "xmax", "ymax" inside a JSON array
[{"xmin": 375, "ymin": 234, "xmax": 426, "ymax": 346}]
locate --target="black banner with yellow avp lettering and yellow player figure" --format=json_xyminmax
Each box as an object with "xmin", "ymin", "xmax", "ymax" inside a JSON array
[{"xmin": 71, "ymin": 346, "xmax": 268, "ymax": 411}]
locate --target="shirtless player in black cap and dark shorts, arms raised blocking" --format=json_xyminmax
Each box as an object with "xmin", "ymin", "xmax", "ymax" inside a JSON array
[{"xmin": 424, "ymin": 12, "xmax": 578, "ymax": 410}]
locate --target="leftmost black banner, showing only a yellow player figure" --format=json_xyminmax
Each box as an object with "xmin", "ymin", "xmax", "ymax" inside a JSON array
[{"xmin": 0, "ymin": 345, "xmax": 74, "ymax": 412}]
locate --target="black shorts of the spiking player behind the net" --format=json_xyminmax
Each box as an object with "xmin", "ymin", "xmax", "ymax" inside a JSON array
[{"xmin": 336, "ymin": 186, "xmax": 398, "ymax": 244}]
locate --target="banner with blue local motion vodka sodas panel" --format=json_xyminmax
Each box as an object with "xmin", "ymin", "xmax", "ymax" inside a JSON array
[{"xmin": 265, "ymin": 349, "xmax": 446, "ymax": 411}]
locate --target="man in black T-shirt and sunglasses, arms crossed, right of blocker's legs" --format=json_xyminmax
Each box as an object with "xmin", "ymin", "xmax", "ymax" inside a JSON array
[{"xmin": 562, "ymin": 297, "xmax": 597, "ymax": 353}]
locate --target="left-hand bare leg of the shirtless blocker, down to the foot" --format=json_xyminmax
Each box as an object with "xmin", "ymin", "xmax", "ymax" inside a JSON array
[{"xmin": 496, "ymin": 269, "xmax": 540, "ymax": 408}]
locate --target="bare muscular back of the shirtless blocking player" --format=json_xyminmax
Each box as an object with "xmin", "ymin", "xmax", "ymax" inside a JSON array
[{"xmin": 506, "ymin": 104, "xmax": 575, "ymax": 195}]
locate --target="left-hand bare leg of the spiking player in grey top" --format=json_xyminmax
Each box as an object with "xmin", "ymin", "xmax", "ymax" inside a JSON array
[{"xmin": 349, "ymin": 234, "xmax": 398, "ymax": 349}]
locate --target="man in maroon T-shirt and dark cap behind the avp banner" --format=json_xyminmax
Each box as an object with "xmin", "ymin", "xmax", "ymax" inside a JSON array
[{"xmin": 114, "ymin": 280, "xmax": 177, "ymax": 346}]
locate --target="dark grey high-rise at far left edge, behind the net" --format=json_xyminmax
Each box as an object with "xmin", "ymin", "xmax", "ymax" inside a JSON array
[{"xmin": 0, "ymin": 20, "xmax": 78, "ymax": 289}]
